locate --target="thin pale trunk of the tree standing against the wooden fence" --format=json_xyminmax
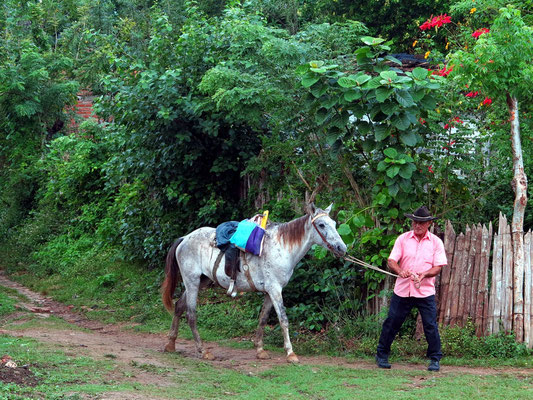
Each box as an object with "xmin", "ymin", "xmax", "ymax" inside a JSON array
[{"xmin": 507, "ymin": 93, "xmax": 527, "ymax": 342}]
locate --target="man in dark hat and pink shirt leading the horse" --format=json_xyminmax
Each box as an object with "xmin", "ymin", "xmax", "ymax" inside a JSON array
[{"xmin": 376, "ymin": 206, "xmax": 447, "ymax": 371}]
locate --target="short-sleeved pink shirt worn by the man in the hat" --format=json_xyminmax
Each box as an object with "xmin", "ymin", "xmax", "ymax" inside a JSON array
[{"xmin": 389, "ymin": 231, "xmax": 448, "ymax": 297}]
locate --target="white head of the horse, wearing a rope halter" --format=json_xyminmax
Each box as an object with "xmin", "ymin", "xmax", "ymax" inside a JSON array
[{"xmin": 307, "ymin": 203, "xmax": 346, "ymax": 257}]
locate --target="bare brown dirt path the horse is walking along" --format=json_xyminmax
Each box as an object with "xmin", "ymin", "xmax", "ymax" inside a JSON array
[{"xmin": 0, "ymin": 271, "xmax": 533, "ymax": 398}]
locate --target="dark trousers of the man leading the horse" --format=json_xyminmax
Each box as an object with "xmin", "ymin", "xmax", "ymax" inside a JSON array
[{"xmin": 376, "ymin": 293, "xmax": 442, "ymax": 361}]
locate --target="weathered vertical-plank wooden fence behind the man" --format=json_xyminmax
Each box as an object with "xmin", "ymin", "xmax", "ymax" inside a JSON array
[{"xmin": 369, "ymin": 214, "xmax": 533, "ymax": 348}]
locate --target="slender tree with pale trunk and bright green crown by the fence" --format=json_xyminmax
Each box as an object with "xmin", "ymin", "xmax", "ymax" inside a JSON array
[{"xmin": 450, "ymin": 6, "xmax": 533, "ymax": 341}]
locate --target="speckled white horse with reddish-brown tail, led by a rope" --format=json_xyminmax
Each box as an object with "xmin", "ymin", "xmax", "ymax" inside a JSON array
[{"xmin": 162, "ymin": 204, "xmax": 346, "ymax": 363}]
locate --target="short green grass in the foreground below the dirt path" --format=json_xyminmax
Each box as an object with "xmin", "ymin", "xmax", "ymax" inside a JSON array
[{"xmin": 0, "ymin": 335, "xmax": 533, "ymax": 400}]
